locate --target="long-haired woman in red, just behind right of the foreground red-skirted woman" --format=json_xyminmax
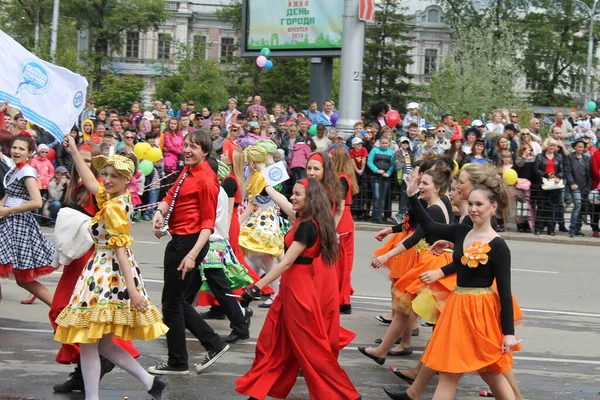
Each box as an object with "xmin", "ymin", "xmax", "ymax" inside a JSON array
[{"xmin": 331, "ymin": 147, "xmax": 358, "ymax": 314}]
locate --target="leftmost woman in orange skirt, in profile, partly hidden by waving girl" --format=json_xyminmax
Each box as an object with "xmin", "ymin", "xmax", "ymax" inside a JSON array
[{"xmin": 358, "ymin": 168, "xmax": 452, "ymax": 365}]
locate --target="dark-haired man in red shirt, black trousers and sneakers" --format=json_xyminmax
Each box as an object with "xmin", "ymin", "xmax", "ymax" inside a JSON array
[{"xmin": 148, "ymin": 129, "xmax": 229, "ymax": 375}]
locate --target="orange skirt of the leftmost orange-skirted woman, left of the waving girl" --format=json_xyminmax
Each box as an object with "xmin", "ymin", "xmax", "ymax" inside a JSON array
[{"xmin": 392, "ymin": 248, "xmax": 456, "ymax": 314}]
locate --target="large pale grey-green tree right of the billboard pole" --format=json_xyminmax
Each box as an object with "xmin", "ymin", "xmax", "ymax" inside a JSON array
[{"xmin": 424, "ymin": 22, "xmax": 522, "ymax": 120}]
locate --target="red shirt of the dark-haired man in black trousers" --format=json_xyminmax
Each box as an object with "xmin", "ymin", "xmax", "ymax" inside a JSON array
[{"xmin": 163, "ymin": 161, "xmax": 219, "ymax": 235}]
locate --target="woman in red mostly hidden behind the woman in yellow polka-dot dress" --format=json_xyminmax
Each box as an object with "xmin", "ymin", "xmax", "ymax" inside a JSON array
[{"xmin": 48, "ymin": 144, "xmax": 140, "ymax": 393}]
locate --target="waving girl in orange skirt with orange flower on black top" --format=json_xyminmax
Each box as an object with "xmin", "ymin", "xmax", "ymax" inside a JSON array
[{"xmin": 392, "ymin": 166, "xmax": 519, "ymax": 399}]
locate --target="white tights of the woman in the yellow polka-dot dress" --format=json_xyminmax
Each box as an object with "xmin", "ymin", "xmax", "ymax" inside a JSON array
[{"xmin": 79, "ymin": 333, "xmax": 154, "ymax": 400}]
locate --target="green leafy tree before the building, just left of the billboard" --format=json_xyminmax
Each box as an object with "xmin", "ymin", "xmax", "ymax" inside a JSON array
[{"xmin": 154, "ymin": 46, "xmax": 229, "ymax": 110}]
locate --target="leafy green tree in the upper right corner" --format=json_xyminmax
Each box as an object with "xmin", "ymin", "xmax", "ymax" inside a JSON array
[{"xmin": 522, "ymin": 0, "xmax": 600, "ymax": 106}]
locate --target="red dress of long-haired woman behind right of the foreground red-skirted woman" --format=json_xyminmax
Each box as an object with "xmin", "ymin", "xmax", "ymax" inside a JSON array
[{"xmin": 335, "ymin": 174, "xmax": 354, "ymax": 305}]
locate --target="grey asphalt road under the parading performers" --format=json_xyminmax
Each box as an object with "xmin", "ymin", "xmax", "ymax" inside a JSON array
[{"xmin": 0, "ymin": 223, "xmax": 600, "ymax": 400}]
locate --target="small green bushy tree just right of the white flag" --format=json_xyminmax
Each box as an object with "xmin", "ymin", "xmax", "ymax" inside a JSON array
[{"xmin": 93, "ymin": 74, "xmax": 146, "ymax": 115}]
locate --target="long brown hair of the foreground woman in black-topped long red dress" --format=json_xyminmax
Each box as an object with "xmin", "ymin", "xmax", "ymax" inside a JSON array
[{"xmin": 300, "ymin": 178, "xmax": 339, "ymax": 268}]
